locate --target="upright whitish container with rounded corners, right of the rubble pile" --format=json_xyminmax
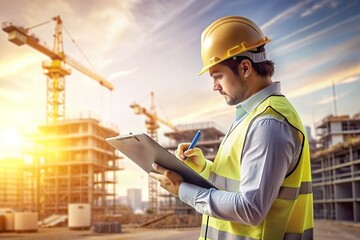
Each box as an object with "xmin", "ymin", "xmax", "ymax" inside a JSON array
[{"xmin": 68, "ymin": 203, "xmax": 91, "ymax": 230}]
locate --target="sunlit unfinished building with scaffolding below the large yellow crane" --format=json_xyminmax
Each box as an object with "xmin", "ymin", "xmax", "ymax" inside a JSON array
[{"xmin": 26, "ymin": 116, "xmax": 121, "ymax": 218}]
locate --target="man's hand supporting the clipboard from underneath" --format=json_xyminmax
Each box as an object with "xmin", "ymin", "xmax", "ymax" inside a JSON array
[{"xmin": 150, "ymin": 163, "xmax": 184, "ymax": 196}]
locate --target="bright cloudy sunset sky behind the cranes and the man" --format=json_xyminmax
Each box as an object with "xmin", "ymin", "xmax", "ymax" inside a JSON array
[{"xmin": 0, "ymin": 0, "xmax": 360, "ymax": 199}]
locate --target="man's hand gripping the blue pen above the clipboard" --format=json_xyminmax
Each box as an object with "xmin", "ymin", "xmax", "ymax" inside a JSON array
[{"xmin": 175, "ymin": 143, "xmax": 206, "ymax": 173}]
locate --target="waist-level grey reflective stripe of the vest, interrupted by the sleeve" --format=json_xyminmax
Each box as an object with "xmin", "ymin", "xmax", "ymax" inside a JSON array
[{"xmin": 209, "ymin": 172, "xmax": 312, "ymax": 200}]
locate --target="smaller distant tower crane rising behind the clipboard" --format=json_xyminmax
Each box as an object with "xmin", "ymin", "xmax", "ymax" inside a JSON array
[{"xmin": 130, "ymin": 92, "xmax": 178, "ymax": 212}]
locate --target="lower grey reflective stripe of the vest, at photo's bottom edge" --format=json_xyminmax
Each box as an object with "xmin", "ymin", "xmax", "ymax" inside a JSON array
[{"xmin": 201, "ymin": 226, "xmax": 313, "ymax": 240}]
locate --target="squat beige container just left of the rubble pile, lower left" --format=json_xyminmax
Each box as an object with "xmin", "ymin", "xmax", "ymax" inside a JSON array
[{"xmin": 14, "ymin": 212, "xmax": 38, "ymax": 232}]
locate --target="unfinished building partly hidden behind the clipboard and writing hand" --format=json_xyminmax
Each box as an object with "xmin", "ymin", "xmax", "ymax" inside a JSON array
[{"xmin": 158, "ymin": 122, "xmax": 225, "ymax": 214}]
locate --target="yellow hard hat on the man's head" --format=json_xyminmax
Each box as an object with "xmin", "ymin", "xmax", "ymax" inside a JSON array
[{"xmin": 199, "ymin": 16, "xmax": 270, "ymax": 75}]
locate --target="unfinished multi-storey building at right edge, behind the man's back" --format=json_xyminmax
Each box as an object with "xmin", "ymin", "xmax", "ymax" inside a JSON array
[{"xmin": 311, "ymin": 114, "xmax": 360, "ymax": 222}]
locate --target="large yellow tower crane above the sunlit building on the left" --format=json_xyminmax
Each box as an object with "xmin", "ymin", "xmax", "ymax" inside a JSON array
[{"xmin": 2, "ymin": 16, "xmax": 114, "ymax": 123}]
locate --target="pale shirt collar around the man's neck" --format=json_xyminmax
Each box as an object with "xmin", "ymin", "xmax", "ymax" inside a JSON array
[{"xmin": 235, "ymin": 82, "xmax": 281, "ymax": 121}]
